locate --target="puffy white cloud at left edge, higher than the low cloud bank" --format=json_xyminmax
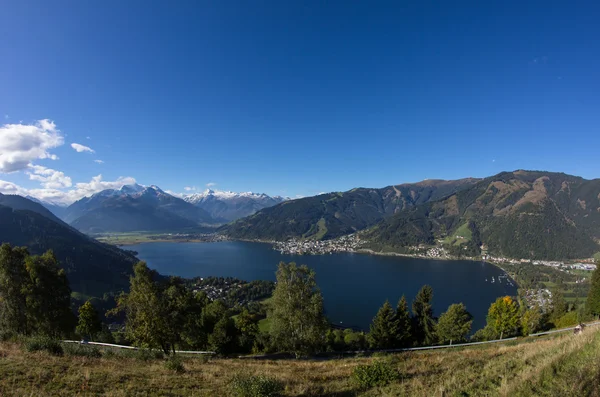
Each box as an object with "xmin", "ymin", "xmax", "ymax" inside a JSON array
[{"xmin": 0, "ymin": 119, "xmax": 64, "ymax": 173}]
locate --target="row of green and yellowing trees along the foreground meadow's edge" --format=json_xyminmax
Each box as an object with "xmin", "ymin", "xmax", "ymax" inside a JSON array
[{"xmin": 0, "ymin": 244, "xmax": 600, "ymax": 356}]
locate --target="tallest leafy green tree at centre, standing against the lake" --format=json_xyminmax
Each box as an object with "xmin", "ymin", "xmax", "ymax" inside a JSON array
[{"xmin": 268, "ymin": 262, "xmax": 327, "ymax": 357}]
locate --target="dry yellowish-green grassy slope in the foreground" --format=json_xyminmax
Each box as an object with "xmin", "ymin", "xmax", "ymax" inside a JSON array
[{"xmin": 0, "ymin": 328, "xmax": 600, "ymax": 397}]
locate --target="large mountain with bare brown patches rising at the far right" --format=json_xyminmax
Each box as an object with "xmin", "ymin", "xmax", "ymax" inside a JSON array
[{"xmin": 363, "ymin": 171, "xmax": 600, "ymax": 259}]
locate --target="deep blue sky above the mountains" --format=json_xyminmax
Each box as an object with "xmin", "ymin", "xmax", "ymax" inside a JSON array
[{"xmin": 0, "ymin": 1, "xmax": 600, "ymax": 203}]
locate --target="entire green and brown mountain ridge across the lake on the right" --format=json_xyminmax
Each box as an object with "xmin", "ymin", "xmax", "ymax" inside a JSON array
[{"xmin": 221, "ymin": 170, "xmax": 600, "ymax": 259}]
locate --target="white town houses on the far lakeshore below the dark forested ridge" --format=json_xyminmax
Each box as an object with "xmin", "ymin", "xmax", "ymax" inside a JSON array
[{"xmin": 273, "ymin": 234, "xmax": 362, "ymax": 255}]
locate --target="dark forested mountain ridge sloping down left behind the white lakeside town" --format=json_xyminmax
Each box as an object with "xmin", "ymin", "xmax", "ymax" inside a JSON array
[{"xmin": 221, "ymin": 178, "xmax": 478, "ymax": 241}]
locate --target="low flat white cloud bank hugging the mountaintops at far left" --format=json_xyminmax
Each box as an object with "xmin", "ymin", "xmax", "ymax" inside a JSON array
[{"xmin": 0, "ymin": 173, "xmax": 135, "ymax": 205}]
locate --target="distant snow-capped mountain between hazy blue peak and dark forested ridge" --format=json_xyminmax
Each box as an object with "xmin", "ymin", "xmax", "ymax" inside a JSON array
[{"xmin": 183, "ymin": 189, "xmax": 285, "ymax": 222}]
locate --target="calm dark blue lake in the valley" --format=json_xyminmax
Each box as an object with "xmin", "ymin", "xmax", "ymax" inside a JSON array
[{"xmin": 125, "ymin": 241, "xmax": 517, "ymax": 331}]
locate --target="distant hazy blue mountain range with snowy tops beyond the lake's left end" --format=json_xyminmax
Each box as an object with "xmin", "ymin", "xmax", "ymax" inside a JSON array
[{"xmin": 32, "ymin": 184, "xmax": 285, "ymax": 234}]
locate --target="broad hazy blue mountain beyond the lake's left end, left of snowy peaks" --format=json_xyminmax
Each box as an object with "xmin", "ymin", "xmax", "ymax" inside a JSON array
[{"xmin": 63, "ymin": 185, "xmax": 214, "ymax": 233}]
